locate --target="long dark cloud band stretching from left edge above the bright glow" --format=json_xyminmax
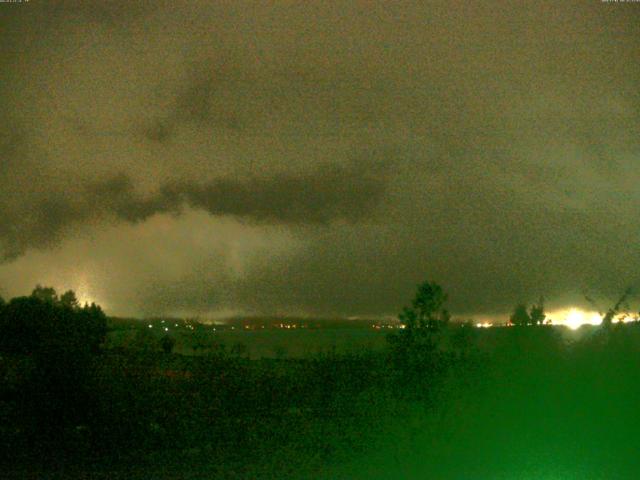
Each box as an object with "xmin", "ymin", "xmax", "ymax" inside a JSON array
[{"xmin": 0, "ymin": 159, "xmax": 384, "ymax": 259}]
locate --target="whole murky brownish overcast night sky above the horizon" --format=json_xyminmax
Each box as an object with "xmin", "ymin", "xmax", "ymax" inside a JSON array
[{"xmin": 0, "ymin": 0, "xmax": 640, "ymax": 315}]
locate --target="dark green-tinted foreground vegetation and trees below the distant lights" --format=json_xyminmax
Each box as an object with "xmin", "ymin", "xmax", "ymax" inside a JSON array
[{"xmin": 0, "ymin": 284, "xmax": 640, "ymax": 480}]
